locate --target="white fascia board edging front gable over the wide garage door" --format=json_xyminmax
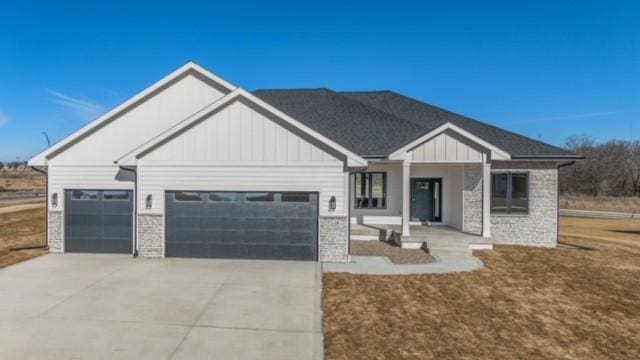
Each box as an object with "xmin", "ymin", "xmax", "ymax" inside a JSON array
[{"xmin": 114, "ymin": 88, "xmax": 367, "ymax": 167}]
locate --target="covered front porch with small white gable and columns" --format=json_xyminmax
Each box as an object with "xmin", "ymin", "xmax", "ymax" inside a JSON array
[{"xmin": 351, "ymin": 125, "xmax": 508, "ymax": 247}]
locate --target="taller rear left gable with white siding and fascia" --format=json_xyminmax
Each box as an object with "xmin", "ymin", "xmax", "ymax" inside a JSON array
[{"xmin": 29, "ymin": 61, "xmax": 236, "ymax": 166}]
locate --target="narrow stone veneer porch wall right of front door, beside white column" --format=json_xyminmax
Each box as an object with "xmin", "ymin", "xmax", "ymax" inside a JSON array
[{"xmin": 462, "ymin": 164, "xmax": 482, "ymax": 235}]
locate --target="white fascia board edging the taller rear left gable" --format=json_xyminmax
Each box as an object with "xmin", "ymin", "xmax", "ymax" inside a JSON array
[{"xmin": 29, "ymin": 61, "xmax": 237, "ymax": 166}]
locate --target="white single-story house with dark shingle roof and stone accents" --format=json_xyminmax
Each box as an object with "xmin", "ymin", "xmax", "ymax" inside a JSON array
[{"xmin": 29, "ymin": 62, "xmax": 577, "ymax": 262}]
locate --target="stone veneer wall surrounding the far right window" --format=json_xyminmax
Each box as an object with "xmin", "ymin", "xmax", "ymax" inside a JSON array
[{"xmin": 491, "ymin": 162, "xmax": 558, "ymax": 246}]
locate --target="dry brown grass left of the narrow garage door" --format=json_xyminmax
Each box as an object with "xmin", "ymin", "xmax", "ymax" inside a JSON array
[{"xmin": 0, "ymin": 206, "xmax": 47, "ymax": 268}]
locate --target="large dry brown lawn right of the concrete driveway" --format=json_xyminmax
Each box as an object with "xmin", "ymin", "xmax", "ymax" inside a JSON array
[{"xmin": 323, "ymin": 219, "xmax": 640, "ymax": 359}]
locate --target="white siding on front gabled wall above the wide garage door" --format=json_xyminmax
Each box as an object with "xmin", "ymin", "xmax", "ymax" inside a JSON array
[{"xmin": 138, "ymin": 101, "xmax": 348, "ymax": 216}]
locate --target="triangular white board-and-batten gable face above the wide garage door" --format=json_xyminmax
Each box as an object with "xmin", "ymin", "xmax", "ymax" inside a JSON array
[{"xmin": 142, "ymin": 99, "xmax": 339, "ymax": 163}]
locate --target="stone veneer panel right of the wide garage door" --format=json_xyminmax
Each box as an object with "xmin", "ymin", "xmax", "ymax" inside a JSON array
[{"xmin": 318, "ymin": 216, "xmax": 349, "ymax": 262}]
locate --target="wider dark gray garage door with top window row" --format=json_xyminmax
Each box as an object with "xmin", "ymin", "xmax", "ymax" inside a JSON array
[{"xmin": 165, "ymin": 191, "xmax": 318, "ymax": 260}]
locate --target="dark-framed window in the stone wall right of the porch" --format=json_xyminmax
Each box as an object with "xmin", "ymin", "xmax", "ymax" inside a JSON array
[{"xmin": 491, "ymin": 172, "xmax": 529, "ymax": 214}]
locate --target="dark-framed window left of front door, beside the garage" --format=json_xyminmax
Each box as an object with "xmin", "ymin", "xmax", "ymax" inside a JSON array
[{"xmin": 354, "ymin": 172, "xmax": 387, "ymax": 209}]
